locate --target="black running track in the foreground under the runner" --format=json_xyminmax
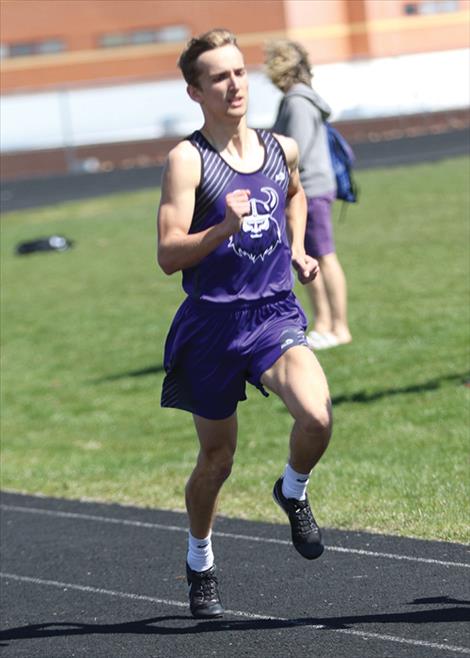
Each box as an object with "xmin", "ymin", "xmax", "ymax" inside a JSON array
[{"xmin": 0, "ymin": 493, "xmax": 470, "ymax": 658}]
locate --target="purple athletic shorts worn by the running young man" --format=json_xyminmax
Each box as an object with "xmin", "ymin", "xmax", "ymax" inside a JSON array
[{"xmin": 161, "ymin": 292, "xmax": 307, "ymax": 420}]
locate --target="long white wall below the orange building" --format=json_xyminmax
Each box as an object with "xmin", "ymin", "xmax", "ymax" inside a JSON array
[{"xmin": 0, "ymin": 50, "xmax": 470, "ymax": 152}]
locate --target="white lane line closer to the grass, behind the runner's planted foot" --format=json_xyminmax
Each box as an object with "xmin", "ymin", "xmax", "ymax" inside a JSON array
[{"xmin": 0, "ymin": 505, "xmax": 470, "ymax": 569}]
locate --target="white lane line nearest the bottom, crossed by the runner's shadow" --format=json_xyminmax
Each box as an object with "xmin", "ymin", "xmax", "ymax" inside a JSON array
[{"xmin": 0, "ymin": 572, "xmax": 470, "ymax": 655}]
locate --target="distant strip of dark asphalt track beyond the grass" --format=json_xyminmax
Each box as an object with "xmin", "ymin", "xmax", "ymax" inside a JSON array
[{"xmin": 0, "ymin": 129, "xmax": 470, "ymax": 212}]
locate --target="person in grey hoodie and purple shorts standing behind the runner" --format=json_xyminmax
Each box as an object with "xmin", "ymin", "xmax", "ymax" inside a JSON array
[{"xmin": 265, "ymin": 40, "xmax": 351, "ymax": 349}]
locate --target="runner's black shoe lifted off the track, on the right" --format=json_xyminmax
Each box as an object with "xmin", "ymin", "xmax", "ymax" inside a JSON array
[{"xmin": 273, "ymin": 478, "xmax": 324, "ymax": 560}]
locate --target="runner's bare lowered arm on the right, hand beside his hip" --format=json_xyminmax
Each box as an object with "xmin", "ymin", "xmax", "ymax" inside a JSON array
[{"xmin": 276, "ymin": 135, "xmax": 319, "ymax": 283}]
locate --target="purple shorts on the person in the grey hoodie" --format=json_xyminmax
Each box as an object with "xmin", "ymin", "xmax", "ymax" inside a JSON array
[{"xmin": 305, "ymin": 192, "xmax": 335, "ymax": 258}]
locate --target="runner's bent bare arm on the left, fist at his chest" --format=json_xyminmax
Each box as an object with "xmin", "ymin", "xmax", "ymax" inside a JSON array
[{"xmin": 157, "ymin": 141, "xmax": 249, "ymax": 274}]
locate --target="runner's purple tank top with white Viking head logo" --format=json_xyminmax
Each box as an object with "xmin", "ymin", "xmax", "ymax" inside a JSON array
[{"xmin": 183, "ymin": 130, "xmax": 293, "ymax": 303}]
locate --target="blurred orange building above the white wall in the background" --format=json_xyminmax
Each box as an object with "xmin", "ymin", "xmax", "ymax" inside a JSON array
[{"xmin": 0, "ymin": 0, "xmax": 470, "ymax": 93}]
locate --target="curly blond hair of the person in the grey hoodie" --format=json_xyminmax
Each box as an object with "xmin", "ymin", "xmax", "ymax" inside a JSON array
[{"xmin": 265, "ymin": 39, "xmax": 312, "ymax": 92}]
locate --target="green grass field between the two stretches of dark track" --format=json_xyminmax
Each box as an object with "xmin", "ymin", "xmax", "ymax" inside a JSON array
[{"xmin": 2, "ymin": 158, "xmax": 470, "ymax": 541}]
